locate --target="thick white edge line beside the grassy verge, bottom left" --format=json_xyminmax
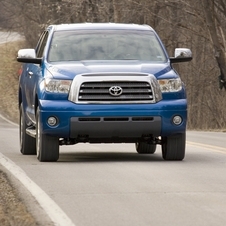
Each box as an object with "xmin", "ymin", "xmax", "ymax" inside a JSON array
[{"xmin": 0, "ymin": 153, "xmax": 75, "ymax": 226}]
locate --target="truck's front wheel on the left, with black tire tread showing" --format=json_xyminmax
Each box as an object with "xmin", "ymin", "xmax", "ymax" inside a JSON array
[{"xmin": 36, "ymin": 108, "xmax": 59, "ymax": 162}]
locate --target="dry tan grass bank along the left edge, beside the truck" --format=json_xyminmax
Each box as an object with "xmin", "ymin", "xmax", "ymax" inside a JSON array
[{"xmin": 0, "ymin": 41, "xmax": 25, "ymax": 123}]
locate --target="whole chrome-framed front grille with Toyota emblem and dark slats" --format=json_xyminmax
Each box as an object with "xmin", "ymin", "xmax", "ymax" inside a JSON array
[{"xmin": 68, "ymin": 73, "xmax": 162, "ymax": 104}]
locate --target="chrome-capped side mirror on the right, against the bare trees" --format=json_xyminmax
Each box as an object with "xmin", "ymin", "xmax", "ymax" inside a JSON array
[{"xmin": 170, "ymin": 48, "xmax": 192, "ymax": 63}]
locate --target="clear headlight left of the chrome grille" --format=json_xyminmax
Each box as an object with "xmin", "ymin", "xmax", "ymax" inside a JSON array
[{"xmin": 45, "ymin": 78, "xmax": 72, "ymax": 93}]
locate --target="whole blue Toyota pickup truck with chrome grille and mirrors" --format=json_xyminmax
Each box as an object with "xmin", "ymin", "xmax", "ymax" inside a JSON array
[{"xmin": 17, "ymin": 23, "xmax": 192, "ymax": 161}]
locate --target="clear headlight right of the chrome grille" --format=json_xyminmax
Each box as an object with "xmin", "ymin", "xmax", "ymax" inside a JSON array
[{"xmin": 158, "ymin": 78, "xmax": 182, "ymax": 93}]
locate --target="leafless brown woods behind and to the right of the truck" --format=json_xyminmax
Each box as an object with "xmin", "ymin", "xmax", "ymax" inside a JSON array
[{"xmin": 0, "ymin": 0, "xmax": 226, "ymax": 129}]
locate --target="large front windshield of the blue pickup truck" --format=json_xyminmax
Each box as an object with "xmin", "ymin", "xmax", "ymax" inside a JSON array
[{"xmin": 48, "ymin": 30, "xmax": 166, "ymax": 63}]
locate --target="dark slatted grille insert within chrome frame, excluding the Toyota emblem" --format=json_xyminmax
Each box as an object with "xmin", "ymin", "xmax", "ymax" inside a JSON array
[{"xmin": 78, "ymin": 81, "xmax": 153, "ymax": 102}]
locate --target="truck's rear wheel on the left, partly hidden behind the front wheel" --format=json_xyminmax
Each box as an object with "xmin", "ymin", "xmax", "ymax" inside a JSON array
[{"xmin": 20, "ymin": 103, "xmax": 36, "ymax": 155}]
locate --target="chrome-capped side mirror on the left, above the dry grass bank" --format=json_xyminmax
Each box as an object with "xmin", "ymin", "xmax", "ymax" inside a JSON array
[{"xmin": 17, "ymin": 49, "xmax": 42, "ymax": 64}]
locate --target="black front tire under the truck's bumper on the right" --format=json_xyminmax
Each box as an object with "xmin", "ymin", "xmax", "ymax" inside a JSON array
[{"xmin": 162, "ymin": 133, "xmax": 186, "ymax": 161}]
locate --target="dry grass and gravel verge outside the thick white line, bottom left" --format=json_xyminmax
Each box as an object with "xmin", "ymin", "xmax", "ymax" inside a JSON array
[{"xmin": 0, "ymin": 165, "xmax": 53, "ymax": 226}]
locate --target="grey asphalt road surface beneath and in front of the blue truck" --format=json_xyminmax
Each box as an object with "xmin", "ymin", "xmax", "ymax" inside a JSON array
[{"xmin": 0, "ymin": 115, "xmax": 226, "ymax": 226}]
